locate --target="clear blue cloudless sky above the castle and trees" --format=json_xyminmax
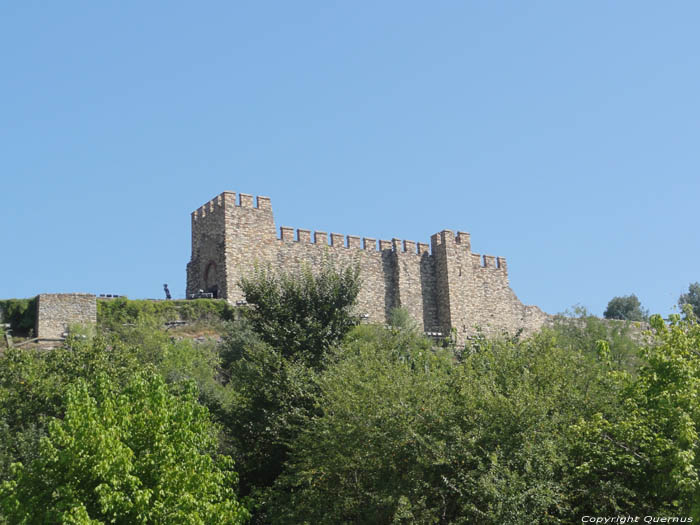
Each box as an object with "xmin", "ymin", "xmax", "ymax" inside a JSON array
[{"xmin": 0, "ymin": 0, "xmax": 700, "ymax": 314}]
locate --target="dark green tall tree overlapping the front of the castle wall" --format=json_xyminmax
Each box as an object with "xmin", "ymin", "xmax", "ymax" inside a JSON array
[{"xmin": 220, "ymin": 262, "xmax": 359, "ymax": 522}]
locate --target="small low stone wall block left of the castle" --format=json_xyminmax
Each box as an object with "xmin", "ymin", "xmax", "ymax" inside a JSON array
[{"xmin": 36, "ymin": 293, "xmax": 97, "ymax": 339}]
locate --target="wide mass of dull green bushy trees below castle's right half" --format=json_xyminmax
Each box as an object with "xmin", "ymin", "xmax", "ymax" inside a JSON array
[{"xmin": 273, "ymin": 326, "xmax": 615, "ymax": 524}]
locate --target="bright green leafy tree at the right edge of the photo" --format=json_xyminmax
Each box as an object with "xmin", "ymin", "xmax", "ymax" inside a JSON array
[{"xmin": 571, "ymin": 314, "xmax": 700, "ymax": 519}]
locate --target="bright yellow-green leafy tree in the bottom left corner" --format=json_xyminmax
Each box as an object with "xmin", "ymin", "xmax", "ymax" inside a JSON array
[{"xmin": 0, "ymin": 371, "xmax": 247, "ymax": 523}]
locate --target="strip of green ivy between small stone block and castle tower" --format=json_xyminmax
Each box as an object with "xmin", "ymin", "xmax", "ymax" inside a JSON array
[{"xmin": 97, "ymin": 297, "xmax": 234, "ymax": 329}]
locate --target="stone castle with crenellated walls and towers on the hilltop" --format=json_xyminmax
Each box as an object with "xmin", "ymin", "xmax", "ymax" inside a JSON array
[{"xmin": 187, "ymin": 192, "xmax": 549, "ymax": 341}]
